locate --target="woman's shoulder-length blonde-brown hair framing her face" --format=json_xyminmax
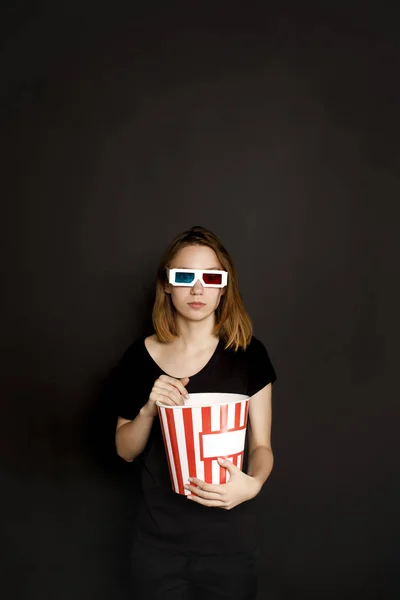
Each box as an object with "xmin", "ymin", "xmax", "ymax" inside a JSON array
[{"xmin": 152, "ymin": 226, "xmax": 253, "ymax": 350}]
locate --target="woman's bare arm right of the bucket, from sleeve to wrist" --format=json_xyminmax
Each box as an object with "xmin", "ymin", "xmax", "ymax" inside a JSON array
[{"xmin": 247, "ymin": 383, "xmax": 274, "ymax": 489}]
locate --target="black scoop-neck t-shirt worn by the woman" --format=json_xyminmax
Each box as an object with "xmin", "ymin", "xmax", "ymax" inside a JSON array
[{"xmin": 112, "ymin": 337, "xmax": 276, "ymax": 554}]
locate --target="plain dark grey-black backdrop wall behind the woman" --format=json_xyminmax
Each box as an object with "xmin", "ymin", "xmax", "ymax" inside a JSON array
[{"xmin": 0, "ymin": 2, "xmax": 400, "ymax": 600}]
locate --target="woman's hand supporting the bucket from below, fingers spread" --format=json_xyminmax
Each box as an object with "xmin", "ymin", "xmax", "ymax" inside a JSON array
[{"xmin": 185, "ymin": 458, "xmax": 261, "ymax": 510}]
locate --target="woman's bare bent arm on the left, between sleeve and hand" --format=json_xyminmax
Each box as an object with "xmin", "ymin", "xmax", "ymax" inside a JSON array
[{"xmin": 115, "ymin": 404, "xmax": 155, "ymax": 462}]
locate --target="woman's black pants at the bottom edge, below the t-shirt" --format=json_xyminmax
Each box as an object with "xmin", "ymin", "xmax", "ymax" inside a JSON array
[{"xmin": 132, "ymin": 540, "xmax": 257, "ymax": 600}]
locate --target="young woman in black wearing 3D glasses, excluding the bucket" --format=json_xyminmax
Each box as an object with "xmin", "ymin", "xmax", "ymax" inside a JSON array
[{"xmin": 113, "ymin": 227, "xmax": 276, "ymax": 600}]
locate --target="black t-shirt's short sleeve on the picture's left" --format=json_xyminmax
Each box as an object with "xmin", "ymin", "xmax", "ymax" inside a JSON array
[{"xmin": 108, "ymin": 340, "xmax": 149, "ymax": 420}]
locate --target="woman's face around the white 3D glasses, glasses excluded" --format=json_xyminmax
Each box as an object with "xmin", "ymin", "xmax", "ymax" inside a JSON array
[{"xmin": 165, "ymin": 245, "xmax": 225, "ymax": 321}]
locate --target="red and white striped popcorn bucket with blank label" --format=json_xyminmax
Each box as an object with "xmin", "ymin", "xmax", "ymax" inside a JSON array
[{"xmin": 157, "ymin": 393, "xmax": 249, "ymax": 495}]
